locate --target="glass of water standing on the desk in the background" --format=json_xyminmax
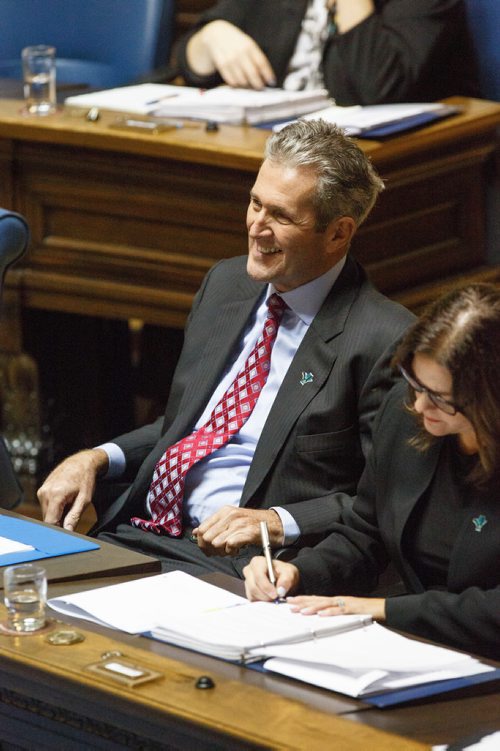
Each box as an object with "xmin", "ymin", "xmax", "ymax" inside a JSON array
[{"xmin": 21, "ymin": 44, "xmax": 56, "ymax": 115}]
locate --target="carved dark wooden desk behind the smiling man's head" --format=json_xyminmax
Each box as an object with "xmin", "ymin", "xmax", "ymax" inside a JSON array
[{"xmin": 0, "ymin": 97, "xmax": 500, "ymax": 334}]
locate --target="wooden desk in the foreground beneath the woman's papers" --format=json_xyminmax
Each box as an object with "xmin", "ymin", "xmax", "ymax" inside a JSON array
[{"xmin": 0, "ymin": 584, "xmax": 500, "ymax": 751}]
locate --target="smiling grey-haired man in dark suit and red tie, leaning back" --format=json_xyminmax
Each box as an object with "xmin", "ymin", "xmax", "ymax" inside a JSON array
[{"xmin": 39, "ymin": 121, "xmax": 412, "ymax": 575}]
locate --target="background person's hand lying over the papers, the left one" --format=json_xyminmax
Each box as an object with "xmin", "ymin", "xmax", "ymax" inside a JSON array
[{"xmin": 186, "ymin": 21, "xmax": 276, "ymax": 89}]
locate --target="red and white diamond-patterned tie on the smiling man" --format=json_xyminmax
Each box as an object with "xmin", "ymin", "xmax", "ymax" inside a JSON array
[{"xmin": 130, "ymin": 294, "xmax": 286, "ymax": 537}]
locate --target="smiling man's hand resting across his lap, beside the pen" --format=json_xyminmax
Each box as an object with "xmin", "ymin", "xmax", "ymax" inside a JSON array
[{"xmin": 193, "ymin": 506, "xmax": 284, "ymax": 556}]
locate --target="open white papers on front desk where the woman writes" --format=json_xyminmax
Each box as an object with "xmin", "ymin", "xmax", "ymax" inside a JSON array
[{"xmin": 49, "ymin": 571, "xmax": 496, "ymax": 696}]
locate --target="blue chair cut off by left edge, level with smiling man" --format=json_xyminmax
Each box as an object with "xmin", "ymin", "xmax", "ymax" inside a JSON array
[{"xmin": 0, "ymin": 209, "xmax": 29, "ymax": 508}]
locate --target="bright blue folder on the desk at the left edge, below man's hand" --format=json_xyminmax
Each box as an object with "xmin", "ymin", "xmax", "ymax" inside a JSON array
[{"xmin": 0, "ymin": 515, "xmax": 99, "ymax": 566}]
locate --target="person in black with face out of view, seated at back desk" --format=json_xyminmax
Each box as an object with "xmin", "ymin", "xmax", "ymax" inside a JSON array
[{"xmin": 177, "ymin": 0, "xmax": 477, "ymax": 105}]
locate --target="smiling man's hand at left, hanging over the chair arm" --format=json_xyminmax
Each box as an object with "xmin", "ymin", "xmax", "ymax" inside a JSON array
[{"xmin": 38, "ymin": 449, "xmax": 108, "ymax": 532}]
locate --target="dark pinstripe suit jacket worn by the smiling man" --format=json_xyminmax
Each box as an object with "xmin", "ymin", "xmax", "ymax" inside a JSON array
[{"xmin": 94, "ymin": 257, "xmax": 413, "ymax": 541}]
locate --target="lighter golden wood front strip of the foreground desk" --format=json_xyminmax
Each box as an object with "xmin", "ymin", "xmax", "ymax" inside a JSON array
[{"xmin": 0, "ymin": 607, "xmax": 428, "ymax": 751}]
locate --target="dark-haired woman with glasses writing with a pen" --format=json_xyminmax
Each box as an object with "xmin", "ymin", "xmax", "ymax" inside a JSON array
[{"xmin": 245, "ymin": 284, "xmax": 500, "ymax": 659}]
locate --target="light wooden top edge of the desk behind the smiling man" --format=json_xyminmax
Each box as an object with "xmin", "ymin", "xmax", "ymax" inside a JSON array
[{"xmin": 0, "ymin": 97, "xmax": 500, "ymax": 171}]
